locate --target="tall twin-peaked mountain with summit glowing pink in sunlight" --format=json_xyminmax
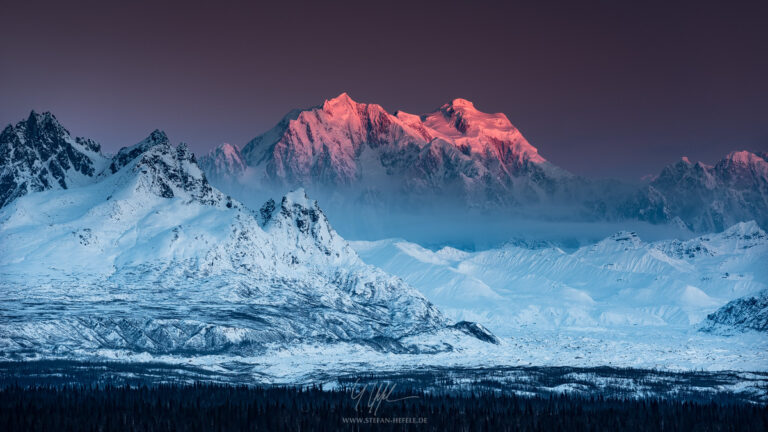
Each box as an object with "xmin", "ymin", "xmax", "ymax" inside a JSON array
[{"xmin": 213, "ymin": 93, "xmax": 570, "ymax": 206}]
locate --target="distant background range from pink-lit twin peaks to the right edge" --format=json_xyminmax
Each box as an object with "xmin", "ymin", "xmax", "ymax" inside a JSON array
[{"xmin": 196, "ymin": 93, "xmax": 768, "ymax": 232}]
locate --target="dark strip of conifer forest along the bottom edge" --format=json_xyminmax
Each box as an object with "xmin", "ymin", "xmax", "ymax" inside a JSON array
[{"xmin": 0, "ymin": 384, "xmax": 768, "ymax": 431}]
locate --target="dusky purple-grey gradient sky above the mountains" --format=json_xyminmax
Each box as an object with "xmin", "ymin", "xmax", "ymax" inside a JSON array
[{"xmin": 0, "ymin": 0, "xmax": 768, "ymax": 179}]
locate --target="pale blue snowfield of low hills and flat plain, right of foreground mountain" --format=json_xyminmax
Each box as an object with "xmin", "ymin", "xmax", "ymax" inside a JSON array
[{"xmin": 351, "ymin": 226, "xmax": 768, "ymax": 371}]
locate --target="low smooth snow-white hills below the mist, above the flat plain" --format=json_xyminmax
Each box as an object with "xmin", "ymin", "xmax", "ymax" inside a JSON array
[{"xmin": 352, "ymin": 222, "xmax": 768, "ymax": 338}]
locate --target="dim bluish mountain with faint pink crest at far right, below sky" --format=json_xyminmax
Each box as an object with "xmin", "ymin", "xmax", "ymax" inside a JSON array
[{"xmin": 622, "ymin": 151, "xmax": 768, "ymax": 232}]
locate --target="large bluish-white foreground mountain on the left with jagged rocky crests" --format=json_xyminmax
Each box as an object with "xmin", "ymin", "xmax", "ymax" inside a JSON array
[{"xmin": 0, "ymin": 125, "xmax": 492, "ymax": 358}]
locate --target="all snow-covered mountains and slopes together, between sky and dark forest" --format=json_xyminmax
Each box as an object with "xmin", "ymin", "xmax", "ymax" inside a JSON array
[{"xmin": 0, "ymin": 107, "xmax": 768, "ymax": 375}]
